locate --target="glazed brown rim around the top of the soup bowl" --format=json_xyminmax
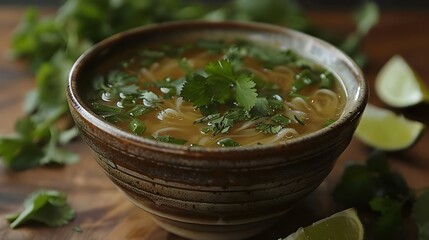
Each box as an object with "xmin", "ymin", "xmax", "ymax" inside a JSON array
[{"xmin": 67, "ymin": 20, "xmax": 368, "ymax": 154}]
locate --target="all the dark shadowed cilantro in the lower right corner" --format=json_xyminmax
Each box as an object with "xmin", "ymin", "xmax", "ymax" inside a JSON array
[{"xmin": 332, "ymin": 150, "xmax": 429, "ymax": 240}]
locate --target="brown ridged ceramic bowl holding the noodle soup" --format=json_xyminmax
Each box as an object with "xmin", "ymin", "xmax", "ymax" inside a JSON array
[{"xmin": 67, "ymin": 21, "xmax": 368, "ymax": 239}]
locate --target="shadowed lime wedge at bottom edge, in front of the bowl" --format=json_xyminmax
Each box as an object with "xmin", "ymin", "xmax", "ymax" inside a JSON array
[{"xmin": 283, "ymin": 208, "xmax": 364, "ymax": 240}]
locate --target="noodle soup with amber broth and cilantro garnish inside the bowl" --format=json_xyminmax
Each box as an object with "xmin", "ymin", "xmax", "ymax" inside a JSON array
[{"xmin": 89, "ymin": 40, "xmax": 345, "ymax": 147}]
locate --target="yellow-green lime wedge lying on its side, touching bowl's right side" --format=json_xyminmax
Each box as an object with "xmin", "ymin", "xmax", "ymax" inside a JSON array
[{"xmin": 355, "ymin": 104, "xmax": 424, "ymax": 151}]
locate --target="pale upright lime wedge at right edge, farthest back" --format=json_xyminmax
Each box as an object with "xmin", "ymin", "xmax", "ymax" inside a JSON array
[{"xmin": 375, "ymin": 55, "xmax": 429, "ymax": 107}]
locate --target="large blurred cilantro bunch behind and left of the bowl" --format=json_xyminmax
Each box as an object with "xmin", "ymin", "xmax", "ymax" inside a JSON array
[{"xmin": 0, "ymin": 0, "xmax": 378, "ymax": 170}]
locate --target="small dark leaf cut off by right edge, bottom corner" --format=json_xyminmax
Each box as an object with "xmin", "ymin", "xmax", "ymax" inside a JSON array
[{"xmin": 412, "ymin": 190, "xmax": 429, "ymax": 240}]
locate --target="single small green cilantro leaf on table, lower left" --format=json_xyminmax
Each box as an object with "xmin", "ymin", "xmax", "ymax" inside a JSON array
[{"xmin": 6, "ymin": 190, "xmax": 75, "ymax": 228}]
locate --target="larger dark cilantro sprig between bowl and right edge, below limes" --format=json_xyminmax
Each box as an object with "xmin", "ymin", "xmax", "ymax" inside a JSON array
[{"xmin": 333, "ymin": 150, "xmax": 414, "ymax": 239}]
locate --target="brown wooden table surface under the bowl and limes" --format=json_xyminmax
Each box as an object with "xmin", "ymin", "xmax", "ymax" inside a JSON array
[{"xmin": 0, "ymin": 7, "xmax": 429, "ymax": 240}]
